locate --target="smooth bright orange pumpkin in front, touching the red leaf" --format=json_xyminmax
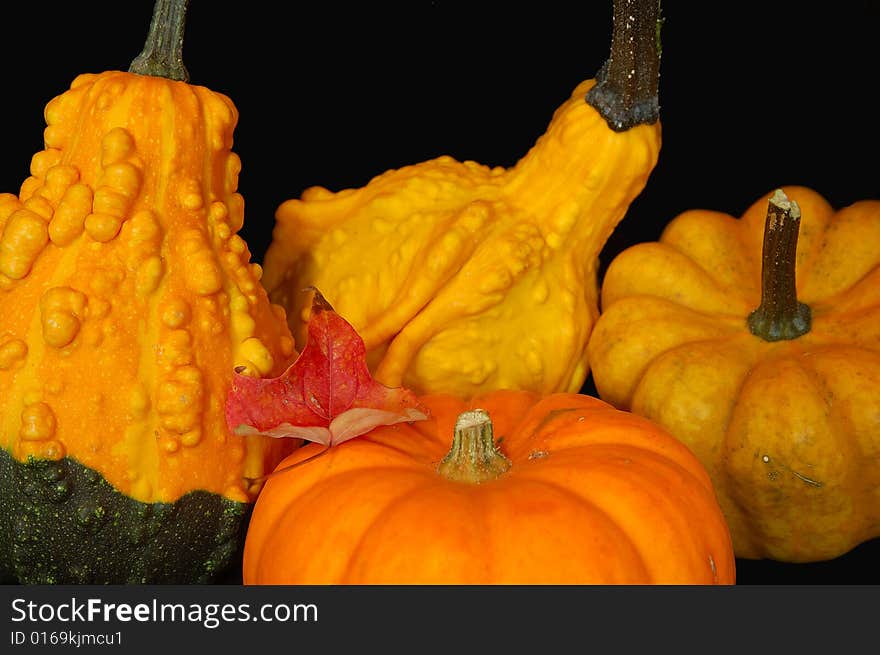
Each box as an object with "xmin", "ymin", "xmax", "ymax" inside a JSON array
[{"xmin": 243, "ymin": 391, "xmax": 735, "ymax": 584}]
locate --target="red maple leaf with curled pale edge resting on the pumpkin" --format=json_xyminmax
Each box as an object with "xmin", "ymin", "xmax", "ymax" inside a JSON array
[{"xmin": 226, "ymin": 289, "xmax": 428, "ymax": 446}]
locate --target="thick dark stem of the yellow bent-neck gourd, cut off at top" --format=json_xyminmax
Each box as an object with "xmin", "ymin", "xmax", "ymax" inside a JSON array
[{"xmin": 586, "ymin": 0, "xmax": 663, "ymax": 132}]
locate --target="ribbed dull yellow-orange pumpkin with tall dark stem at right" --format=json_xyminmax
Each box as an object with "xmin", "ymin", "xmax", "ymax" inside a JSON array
[{"xmin": 589, "ymin": 187, "xmax": 880, "ymax": 562}]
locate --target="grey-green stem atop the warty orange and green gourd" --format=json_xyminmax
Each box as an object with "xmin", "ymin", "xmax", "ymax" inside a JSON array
[{"xmin": 128, "ymin": 0, "xmax": 189, "ymax": 82}]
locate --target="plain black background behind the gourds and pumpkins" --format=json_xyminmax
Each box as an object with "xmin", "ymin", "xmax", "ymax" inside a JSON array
[{"xmin": 0, "ymin": 0, "xmax": 880, "ymax": 584}]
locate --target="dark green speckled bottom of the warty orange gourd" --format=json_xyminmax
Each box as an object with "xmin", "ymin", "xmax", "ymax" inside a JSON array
[{"xmin": 0, "ymin": 449, "xmax": 251, "ymax": 584}]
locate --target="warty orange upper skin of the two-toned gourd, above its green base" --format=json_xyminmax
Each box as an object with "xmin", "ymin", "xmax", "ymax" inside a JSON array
[{"xmin": 0, "ymin": 71, "xmax": 293, "ymax": 502}]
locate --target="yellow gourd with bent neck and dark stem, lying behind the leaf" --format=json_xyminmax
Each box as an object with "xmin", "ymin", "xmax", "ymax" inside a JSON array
[{"xmin": 263, "ymin": 0, "xmax": 660, "ymax": 396}]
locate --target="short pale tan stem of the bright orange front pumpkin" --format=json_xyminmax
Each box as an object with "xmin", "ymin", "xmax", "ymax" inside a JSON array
[{"xmin": 437, "ymin": 409, "xmax": 510, "ymax": 484}]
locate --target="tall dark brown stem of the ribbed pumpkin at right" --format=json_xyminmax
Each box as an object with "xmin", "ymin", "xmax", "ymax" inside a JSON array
[{"xmin": 748, "ymin": 189, "xmax": 812, "ymax": 341}]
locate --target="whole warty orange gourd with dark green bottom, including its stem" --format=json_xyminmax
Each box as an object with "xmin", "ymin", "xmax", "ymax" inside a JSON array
[{"xmin": 0, "ymin": 0, "xmax": 294, "ymax": 583}]
